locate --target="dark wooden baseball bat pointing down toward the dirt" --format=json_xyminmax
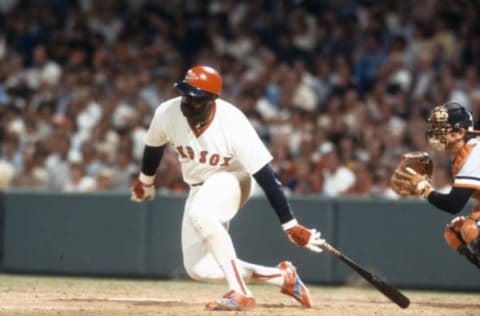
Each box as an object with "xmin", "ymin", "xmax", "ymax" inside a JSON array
[{"xmin": 320, "ymin": 241, "xmax": 410, "ymax": 308}]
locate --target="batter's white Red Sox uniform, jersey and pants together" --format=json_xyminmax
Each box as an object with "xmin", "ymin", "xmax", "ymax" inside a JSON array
[{"xmin": 145, "ymin": 97, "xmax": 283, "ymax": 295}]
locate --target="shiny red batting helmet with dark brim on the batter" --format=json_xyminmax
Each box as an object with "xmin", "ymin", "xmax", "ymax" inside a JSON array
[{"xmin": 174, "ymin": 66, "xmax": 222, "ymax": 97}]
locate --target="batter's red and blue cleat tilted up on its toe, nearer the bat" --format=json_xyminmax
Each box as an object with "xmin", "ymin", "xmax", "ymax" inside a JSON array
[{"xmin": 278, "ymin": 261, "xmax": 312, "ymax": 308}]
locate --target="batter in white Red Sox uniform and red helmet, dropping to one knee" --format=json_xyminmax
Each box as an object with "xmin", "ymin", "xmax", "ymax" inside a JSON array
[{"xmin": 131, "ymin": 66, "xmax": 324, "ymax": 310}]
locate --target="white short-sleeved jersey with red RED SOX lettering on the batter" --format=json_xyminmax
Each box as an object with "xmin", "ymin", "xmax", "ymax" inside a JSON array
[{"xmin": 145, "ymin": 97, "xmax": 272, "ymax": 185}]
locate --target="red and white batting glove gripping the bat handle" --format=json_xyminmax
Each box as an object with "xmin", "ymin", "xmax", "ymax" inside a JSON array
[{"xmin": 282, "ymin": 219, "xmax": 325, "ymax": 253}]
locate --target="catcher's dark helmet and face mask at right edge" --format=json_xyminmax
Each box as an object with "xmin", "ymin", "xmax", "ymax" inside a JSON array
[{"xmin": 427, "ymin": 102, "xmax": 473, "ymax": 151}]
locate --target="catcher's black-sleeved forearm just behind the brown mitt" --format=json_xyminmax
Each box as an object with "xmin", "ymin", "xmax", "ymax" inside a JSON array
[{"xmin": 427, "ymin": 187, "xmax": 474, "ymax": 214}]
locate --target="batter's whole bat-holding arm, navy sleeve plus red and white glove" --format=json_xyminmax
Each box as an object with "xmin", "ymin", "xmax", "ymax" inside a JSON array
[{"xmin": 253, "ymin": 163, "xmax": 323, "ymax": 252}]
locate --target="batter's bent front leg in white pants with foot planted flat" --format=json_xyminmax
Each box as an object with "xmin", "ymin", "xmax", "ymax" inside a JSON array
[{"xmin": 182, "ymin": 172, "xmax": 255, "ymax": 309}]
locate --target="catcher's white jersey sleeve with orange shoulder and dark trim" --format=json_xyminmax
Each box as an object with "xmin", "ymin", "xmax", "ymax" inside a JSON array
[{"xmin": 452, "ymin": 138, "xmax": 480, "ymax": 199}]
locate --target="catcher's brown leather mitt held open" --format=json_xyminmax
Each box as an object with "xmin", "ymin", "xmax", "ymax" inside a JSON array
[{"xmin": 390, "ymin": 151, "xmax": 433, "ymax": 197}]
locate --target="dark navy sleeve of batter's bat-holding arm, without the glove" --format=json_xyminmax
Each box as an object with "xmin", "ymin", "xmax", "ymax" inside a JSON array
[{"xmin": 253, "ymin": 164, "xmax": 295, "ymax": 225}]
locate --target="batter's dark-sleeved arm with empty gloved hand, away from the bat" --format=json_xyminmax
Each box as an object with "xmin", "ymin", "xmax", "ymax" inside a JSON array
[{"xmin": 131, "ymin": 145, "xmax": 165, "ymax": 202}]
